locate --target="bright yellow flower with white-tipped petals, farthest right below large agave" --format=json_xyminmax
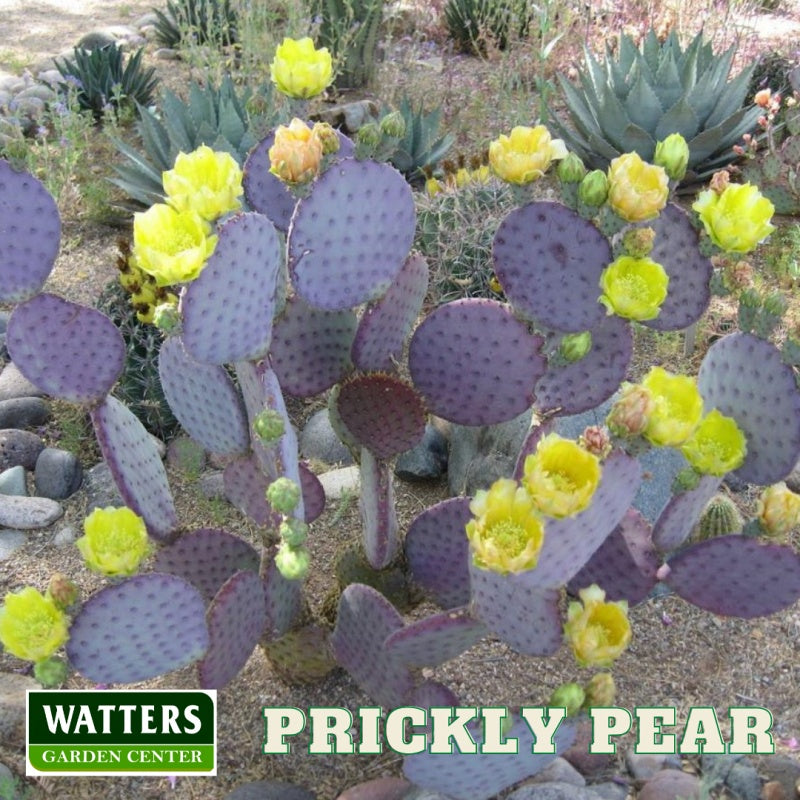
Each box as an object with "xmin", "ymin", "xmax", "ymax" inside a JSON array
[{"xmin": 692, "ymin": 183, "xmax": 775, "ymax": 253}]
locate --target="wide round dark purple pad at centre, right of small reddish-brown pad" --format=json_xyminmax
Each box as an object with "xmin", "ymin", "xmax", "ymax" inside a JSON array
[{"xmin": 408, "ymin": 298, "xmax": 547, "ymax": 425}]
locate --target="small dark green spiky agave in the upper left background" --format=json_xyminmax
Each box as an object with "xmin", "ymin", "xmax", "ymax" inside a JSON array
[{"xmin": 55, "ymin": 44, "xmax": 158, "ymax": 119}]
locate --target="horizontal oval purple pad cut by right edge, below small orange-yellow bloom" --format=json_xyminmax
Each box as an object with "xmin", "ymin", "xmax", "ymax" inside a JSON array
[{"xmin": 665, "ymin": 534, "xmax": 800, "ymax": 619}]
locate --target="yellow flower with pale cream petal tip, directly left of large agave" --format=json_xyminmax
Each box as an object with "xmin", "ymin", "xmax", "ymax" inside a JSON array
[{"xmin": 489, "ymin": 125, "xmax": 567, "ymax": 184}]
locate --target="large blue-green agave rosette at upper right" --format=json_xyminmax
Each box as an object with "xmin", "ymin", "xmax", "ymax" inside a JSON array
[{"xmin": 552, "ymin": 29, "xmax": 761, "ymax": 183}]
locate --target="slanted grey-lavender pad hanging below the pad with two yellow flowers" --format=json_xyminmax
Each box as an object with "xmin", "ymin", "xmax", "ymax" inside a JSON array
[{"xmin": 158, "ymin": 336, "xmax": 250, "ymax": 455}]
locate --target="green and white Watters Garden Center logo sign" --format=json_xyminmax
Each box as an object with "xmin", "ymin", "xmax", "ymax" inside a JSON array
[{"xmin": 26, "ymin": 690, "xmax": 217, "ymax": 775}]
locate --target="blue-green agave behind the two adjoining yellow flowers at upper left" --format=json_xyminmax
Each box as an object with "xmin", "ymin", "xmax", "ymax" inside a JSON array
[{"xmin": 111, "ymin": 75, "xmax": 274, "ymax": 206}]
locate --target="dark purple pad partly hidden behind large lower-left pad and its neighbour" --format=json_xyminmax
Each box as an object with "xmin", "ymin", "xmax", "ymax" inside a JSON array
[{"xmin": 153, "ymin": 528, "xmax": 259, "ymax": 602}]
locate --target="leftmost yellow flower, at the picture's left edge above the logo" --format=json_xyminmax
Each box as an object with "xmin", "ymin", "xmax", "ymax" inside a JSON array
[{"xmin": 0, "ymin": 586, "xmax": 69, "ymax": 663}]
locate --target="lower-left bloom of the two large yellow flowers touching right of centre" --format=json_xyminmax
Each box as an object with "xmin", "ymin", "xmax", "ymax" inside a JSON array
[{"xmin": 466, "ymin": 478, "xmax": 544, "ymax": 575}]
